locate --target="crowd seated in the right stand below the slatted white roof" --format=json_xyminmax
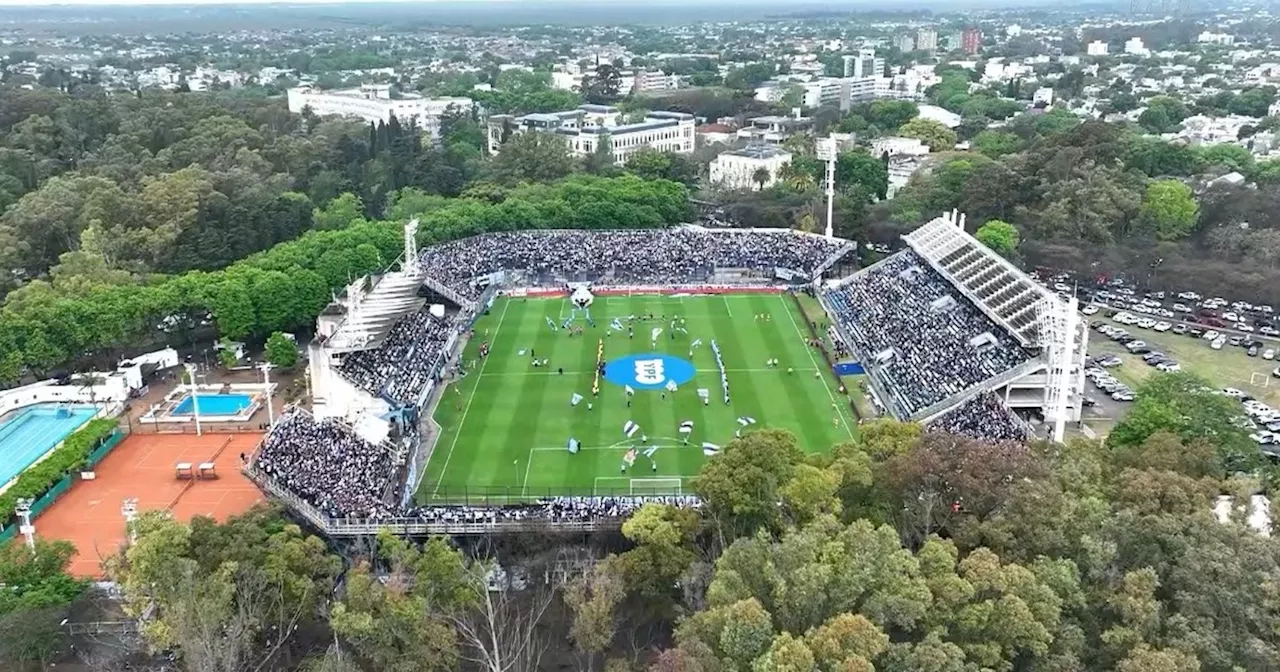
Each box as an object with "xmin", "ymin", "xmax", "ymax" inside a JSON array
[{"xmin": 827, "ymin": 250, "xmax": 1032, "ymax": 415}]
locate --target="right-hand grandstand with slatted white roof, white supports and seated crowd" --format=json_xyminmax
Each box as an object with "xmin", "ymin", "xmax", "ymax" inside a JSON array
[{"xmin": 822, "ymin": 212, "xmax": 1088, "ymax": 442}]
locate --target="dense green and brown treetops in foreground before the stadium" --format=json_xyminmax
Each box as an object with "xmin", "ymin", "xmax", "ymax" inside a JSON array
[{"xmin": 10, "ymin": 374, "xmax": 1280, "ymax": 672}]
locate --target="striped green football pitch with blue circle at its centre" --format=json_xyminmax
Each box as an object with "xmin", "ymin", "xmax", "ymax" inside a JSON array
[{"xmin": 417, "ymin": 294, "xmax": 856, "ymax": 504}]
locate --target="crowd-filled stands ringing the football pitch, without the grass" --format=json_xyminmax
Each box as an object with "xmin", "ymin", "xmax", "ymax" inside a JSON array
[{"xmin": 252, "ymin": 218, "xmax": 1084, "ymax": 532}]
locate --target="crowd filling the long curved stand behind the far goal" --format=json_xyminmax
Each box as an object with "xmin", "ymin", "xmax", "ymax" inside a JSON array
[{"xmin": 421, "ymin": 228, "xmax": 847, "ymax": 300}]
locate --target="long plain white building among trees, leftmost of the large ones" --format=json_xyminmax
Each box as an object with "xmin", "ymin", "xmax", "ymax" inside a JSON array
[{"xmin": 288, "ymin": 84, "xmax": 474, "ymax": 138}]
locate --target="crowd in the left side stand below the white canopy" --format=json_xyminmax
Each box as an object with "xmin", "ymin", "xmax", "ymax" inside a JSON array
[{"xmin": 340, "ymin": 308, "xmax": 452, "ymax": 404}]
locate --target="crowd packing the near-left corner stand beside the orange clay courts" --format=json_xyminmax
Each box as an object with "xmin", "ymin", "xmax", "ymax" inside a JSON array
[{"xmin": 253, "ymin": 412, "xmax": 397, "ymax": 518}]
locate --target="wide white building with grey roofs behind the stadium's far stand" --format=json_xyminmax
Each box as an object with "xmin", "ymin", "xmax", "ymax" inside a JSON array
[{"xmin": 488, "ymin": 105, "xmax": 694, "ymax": 165}]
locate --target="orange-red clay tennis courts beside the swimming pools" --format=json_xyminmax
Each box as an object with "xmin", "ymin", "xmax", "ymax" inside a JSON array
[{"xmin": 35, "ymin": 434, "xmax": 264, "ymax": 579}]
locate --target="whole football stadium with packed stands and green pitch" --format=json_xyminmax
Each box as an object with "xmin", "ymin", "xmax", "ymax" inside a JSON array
[{"xmin": 238, "ymin": 212, "xmax": 1088, "ymax": 536}]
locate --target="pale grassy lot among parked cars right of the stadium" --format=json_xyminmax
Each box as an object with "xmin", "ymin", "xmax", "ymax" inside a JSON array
[{"xmin": 1089, "ymin": 320, "xmax": 1280, "ymax": 406}]
